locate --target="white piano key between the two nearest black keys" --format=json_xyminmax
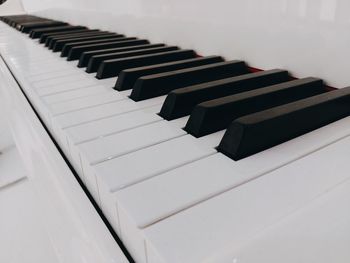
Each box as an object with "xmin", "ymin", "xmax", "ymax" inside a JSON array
[{"xmin": 94, "ymin": 131, "xmax": 224, "ymax": 233}]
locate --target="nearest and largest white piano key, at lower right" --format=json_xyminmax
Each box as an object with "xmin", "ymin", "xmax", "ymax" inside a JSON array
[{"xmin": 142, "ymin": 138, "xmax": 350, "ymax": 262}]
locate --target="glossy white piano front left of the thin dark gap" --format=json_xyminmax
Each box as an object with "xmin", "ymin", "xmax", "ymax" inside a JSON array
[{"xmin": 0, "ymin": 25, "xmax": 127, "ymax": 263}]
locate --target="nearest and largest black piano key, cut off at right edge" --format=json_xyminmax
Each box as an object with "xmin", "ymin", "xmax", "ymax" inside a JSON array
[{"xmin": 218, "ymin": 87, "xmax": 350, "ymax": 160}]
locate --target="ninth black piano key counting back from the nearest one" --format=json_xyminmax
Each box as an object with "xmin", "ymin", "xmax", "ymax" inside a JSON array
[{"xmin": 65, "ymin": 37, "xmax": 149, "ymax": 61}]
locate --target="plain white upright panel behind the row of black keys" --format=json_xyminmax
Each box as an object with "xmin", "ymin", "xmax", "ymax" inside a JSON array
[{"xmin": 18, "ymin": 0, "xmax": 350, "ymax": 87}]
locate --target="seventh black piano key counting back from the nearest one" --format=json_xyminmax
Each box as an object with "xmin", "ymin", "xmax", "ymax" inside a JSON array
[{"xmin": 86, "ymin": 46, "xmax": 179, "ymax": 73}]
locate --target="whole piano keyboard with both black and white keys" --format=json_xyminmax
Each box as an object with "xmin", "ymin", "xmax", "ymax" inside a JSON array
[{"xmin": 1, "ymin": 15, "xmax": 350, "ymax": 262}]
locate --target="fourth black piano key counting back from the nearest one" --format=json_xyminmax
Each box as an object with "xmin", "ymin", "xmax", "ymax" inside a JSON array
[{"xmin": 130, "ymin": 60, "xmax": 249, "ymax": 101}]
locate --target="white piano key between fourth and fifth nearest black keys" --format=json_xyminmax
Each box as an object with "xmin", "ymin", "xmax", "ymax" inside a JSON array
[{"xmin": 49, "ymin": 89, "xmax": 127, "ymax": 116}]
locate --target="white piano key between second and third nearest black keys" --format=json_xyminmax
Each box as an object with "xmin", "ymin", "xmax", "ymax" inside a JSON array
[{"xmin": 76, "ymin": 117, "xmax": 188, "ymax": 200}]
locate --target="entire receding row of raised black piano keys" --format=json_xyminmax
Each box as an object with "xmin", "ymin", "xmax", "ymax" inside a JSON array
[{"xmin": 5, "ymin": 17, "xmax": 350, "ymax": 163}]
